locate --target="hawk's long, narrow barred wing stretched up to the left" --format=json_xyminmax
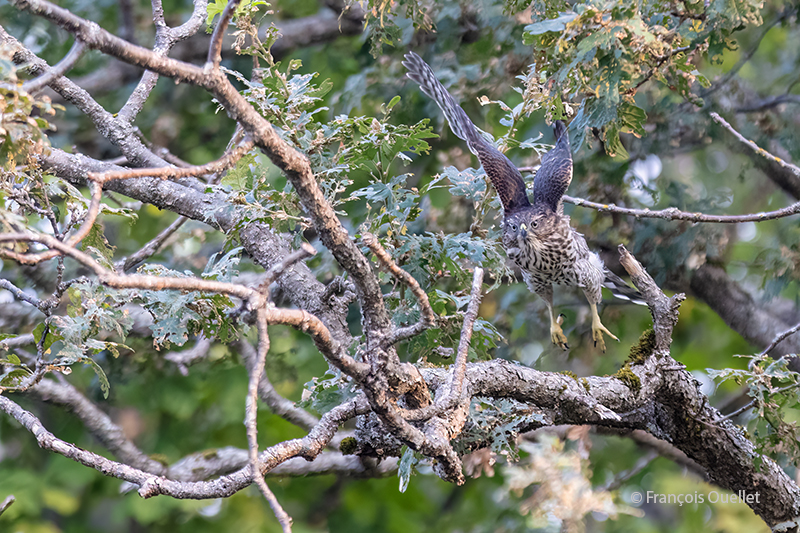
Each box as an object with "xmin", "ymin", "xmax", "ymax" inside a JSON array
[{"xmin": 403, "ymin": 52, "xmax": 532, "ymax": 214}]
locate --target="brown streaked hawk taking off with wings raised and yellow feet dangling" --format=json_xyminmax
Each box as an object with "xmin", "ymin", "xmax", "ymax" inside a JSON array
[{"xmin": 403, "ymin": 52, "xmax": 642, "ymax": 352}]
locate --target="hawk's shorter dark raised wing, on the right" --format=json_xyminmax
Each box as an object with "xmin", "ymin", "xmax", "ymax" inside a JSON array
[{"xmin": 533, "ymin": 120, "xmax": 572, "ymax": 211}]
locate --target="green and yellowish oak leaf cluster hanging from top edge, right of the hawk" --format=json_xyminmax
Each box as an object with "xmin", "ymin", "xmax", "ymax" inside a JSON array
[{"xmin": 523, "ymin": 0, "xmax": 761, "ymax": 152}]
